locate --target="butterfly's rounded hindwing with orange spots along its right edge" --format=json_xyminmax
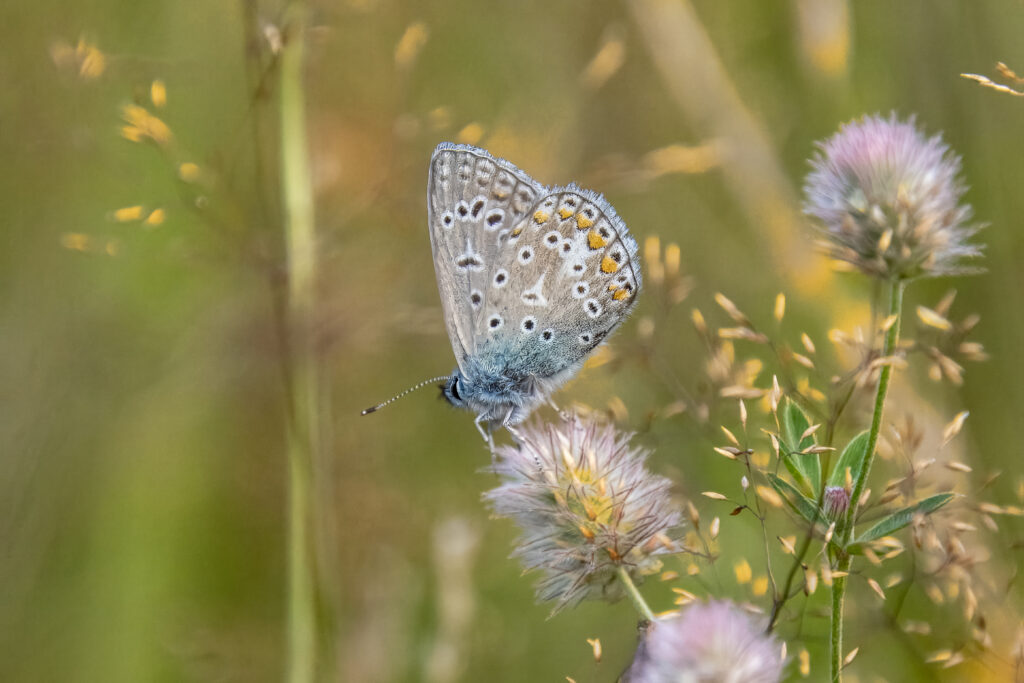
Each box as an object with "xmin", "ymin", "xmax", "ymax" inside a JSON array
[{"xmin": 472, "ymin": 185, "xmax": 641, "ymax": 388}]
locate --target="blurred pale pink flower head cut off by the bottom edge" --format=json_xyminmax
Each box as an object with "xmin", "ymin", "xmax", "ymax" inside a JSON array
[{"xmin": 627, "ymin": 600, "xmax": 784, "ymax": 683}]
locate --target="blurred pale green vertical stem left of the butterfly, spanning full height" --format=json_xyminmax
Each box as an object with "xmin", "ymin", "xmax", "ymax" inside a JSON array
[{"xmin": 280, "ymin": 1, "xmax": 319, "ymax": 683}]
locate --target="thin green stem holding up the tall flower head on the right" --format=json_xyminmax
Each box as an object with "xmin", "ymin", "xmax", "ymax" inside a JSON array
[{"xmin": 829, "ymin": 280, "xmax": 905, "ymax": 683}]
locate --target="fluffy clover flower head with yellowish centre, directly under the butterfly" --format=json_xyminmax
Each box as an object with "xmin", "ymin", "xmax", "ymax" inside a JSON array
[{"xmin": 484, "ymin": 415, "xmax": 681, "ymax": 613}]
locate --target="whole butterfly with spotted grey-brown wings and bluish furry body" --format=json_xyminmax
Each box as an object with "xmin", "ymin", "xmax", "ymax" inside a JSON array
[{"xmin": 427, "ymin": 142, "xmax": 641, "ymax": 436}]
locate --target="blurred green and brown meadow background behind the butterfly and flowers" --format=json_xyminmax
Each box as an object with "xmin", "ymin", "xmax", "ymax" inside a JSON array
[{"xmin": 6, "ymin": 0, "xmax": 1024, "ymax": 682}]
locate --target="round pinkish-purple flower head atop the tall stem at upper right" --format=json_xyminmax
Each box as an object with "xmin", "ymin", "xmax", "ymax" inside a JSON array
[{"xmin": 804, "ymin": 114, "xmax": 981, "ymax": 280}]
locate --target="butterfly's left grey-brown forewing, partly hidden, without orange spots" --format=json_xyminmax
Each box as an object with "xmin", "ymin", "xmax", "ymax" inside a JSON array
[{"xmin": 427, "ymin": 142, "xmax": 547, "ymax": 374}]
